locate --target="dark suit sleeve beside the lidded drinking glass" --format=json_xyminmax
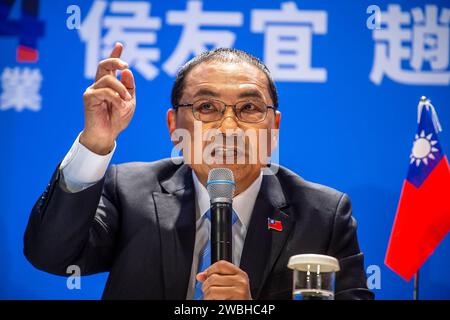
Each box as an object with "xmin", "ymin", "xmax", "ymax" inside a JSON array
[{"xmin": 328, "ymin": 194, "xmax": 374, "ymax": 300}]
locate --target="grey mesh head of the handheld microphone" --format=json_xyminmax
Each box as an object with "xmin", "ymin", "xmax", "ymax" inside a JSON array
[{"xmin": 206, "ymin": 168, "xmax": 236, "ymax": 203}]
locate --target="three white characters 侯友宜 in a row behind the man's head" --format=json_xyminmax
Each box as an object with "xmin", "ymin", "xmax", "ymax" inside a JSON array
[{"xmin": 79, "ymin": 0, "xmax": 327, "ymax": 82}]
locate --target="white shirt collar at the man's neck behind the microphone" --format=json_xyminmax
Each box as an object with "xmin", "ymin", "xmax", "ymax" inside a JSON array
[{"xmin": 192, "ymin": 170, "xmax": 262, "ymax": 229}]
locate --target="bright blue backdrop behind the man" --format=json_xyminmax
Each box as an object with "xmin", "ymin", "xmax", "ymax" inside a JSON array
[{"xmin": 0, "ymin": 0, "xmax": 450, "ymax": 299}]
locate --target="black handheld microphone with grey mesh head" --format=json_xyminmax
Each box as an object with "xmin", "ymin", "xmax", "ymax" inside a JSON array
[{"xmin": 206, "ymin": 168, "xmax": 235, "ymax": 264}]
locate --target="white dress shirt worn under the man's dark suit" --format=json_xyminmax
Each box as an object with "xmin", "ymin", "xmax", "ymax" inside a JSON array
[{"xmin": 60, "ymin": 135, "xmax": 262, "ymax": 299}]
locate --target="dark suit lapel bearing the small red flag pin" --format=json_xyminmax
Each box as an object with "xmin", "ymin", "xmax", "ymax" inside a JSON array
[{"xmin": 240, "ymin": 175, "xmax": 293, "ymax": 299}]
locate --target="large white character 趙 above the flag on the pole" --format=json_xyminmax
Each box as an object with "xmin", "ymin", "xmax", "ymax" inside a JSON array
[{"xmin": 370, "ymin": 5, "xmax": 450, "ymax": 85}]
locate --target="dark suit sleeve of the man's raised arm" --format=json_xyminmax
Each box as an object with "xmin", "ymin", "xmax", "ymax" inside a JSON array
[{"xmin": 24, "ymin": 166, "xmax": 119, "ymax": 276}]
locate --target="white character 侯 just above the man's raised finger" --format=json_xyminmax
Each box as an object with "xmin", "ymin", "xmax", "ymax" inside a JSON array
[{"xmin": 79, "ymin": 0, "xmax": 161, "ymax": 80}]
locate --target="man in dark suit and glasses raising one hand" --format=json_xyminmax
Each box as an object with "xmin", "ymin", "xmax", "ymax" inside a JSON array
[{"xmin": 24, "ymin": 44, "xmax": 373, "ymax": 299}]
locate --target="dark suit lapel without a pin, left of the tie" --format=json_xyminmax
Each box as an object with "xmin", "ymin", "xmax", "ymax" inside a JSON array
[{"xmin": 153, "ymin": 165, "xmax": 195, "ymax": 300}]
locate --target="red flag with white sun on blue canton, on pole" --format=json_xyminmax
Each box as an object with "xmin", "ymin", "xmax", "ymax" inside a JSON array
[{"xmin": 385, "ymin": 97, "xmax": 450, "ymax": 281}]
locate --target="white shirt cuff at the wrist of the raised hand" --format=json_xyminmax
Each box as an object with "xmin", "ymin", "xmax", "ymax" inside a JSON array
[{"xmin": 59, "ymin": 133, "xmax": 116, "ymax": 192}]
